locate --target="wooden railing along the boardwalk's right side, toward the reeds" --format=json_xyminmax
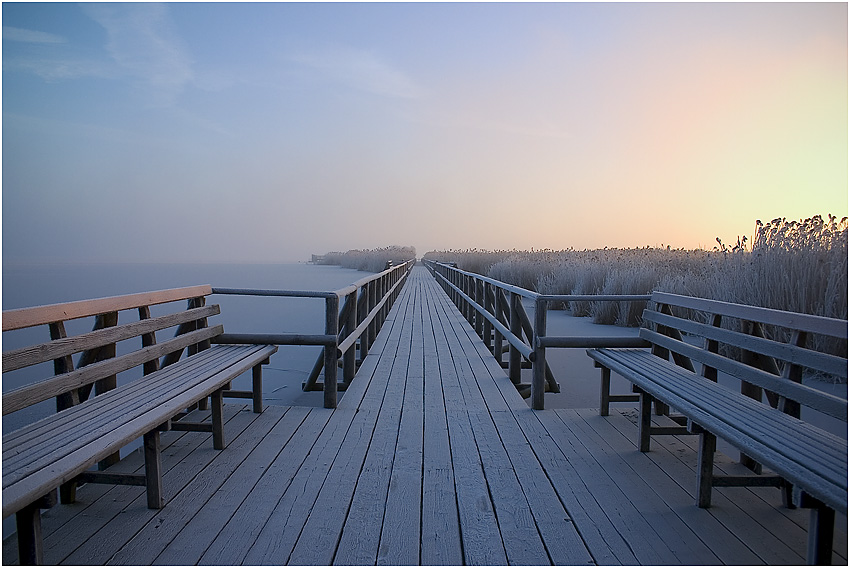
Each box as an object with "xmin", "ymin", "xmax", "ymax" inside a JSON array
[{"xmin": 422, "ymin": 260, "xmax": 650, "ymax": 410}]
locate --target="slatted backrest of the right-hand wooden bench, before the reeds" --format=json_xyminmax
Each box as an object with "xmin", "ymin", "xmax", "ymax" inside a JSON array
[{"xmin": 640, "ymin": 292, "xmax": 847, "ymax": 422}]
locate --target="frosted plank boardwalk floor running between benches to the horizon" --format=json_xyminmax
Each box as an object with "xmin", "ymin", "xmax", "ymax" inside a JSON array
[{"xmin": 3, "ymin": 267, "xmax": 847, "ymax": 565}]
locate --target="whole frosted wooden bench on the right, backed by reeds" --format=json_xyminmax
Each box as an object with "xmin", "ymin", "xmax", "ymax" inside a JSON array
[{"xmin": 587, "ymin": 292, "xmax": 847, "ymax": 564}]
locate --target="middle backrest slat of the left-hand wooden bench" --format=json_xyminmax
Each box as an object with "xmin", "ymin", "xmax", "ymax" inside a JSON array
[{"xmin": 3, "ymin": 304, "xmax": 221, "ymax": 373}]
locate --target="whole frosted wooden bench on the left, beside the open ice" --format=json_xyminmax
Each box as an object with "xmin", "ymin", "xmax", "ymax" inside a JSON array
[{"xmin": 3, "ymin": 286, "xmax": 277, "ymax": 564}]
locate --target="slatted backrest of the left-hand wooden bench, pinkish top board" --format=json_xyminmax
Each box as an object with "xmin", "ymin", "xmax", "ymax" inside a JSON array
[{"xmin": 3, "ymin": 286, "xmax": 224, "ymax": 416}]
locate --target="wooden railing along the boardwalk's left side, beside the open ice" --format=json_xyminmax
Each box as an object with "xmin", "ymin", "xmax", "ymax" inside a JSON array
[{"xmin": 212, "ymin": 260, "xmax": 416, "ymax": 408}]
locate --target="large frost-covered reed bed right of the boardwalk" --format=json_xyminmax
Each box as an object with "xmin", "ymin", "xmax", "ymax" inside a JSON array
[{"xmin": 425, "ymin": 215, "xmax": 848, "ymax": 332}]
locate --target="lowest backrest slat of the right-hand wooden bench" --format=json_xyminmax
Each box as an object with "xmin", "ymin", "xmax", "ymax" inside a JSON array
[{"xmin": 640, "ymin": 328, "xmax": 847, "ymax": 420}]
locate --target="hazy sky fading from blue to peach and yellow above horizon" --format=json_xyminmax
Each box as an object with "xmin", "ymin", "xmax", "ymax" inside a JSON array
[{"xmin": 2, "ymin": 2, "xmax": 848, "ymax": 264}]
